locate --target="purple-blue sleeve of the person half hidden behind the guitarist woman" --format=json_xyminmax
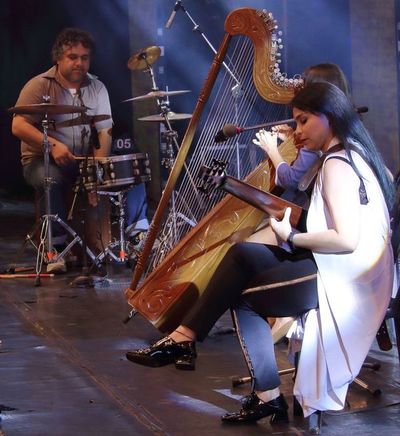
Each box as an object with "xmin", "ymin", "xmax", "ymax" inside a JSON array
[{"xmin": 276, "ymin": 148, "xmax": 318, "ymax": 189}]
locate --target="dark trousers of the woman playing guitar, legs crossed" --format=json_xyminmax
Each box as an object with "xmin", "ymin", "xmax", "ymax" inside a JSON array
[{"xmin": 182, "ymin": 242, "xmax": 318, "ymax": 391}]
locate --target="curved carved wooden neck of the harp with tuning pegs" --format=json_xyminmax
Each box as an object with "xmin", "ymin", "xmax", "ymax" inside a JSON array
[{"xmin": 225, "ymin": 8, "xmax": 303, "ymax": 104}]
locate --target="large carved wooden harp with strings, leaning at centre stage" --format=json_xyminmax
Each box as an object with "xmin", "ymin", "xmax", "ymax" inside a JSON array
[{"xmin": 125, "ymin": 8, "xmax": 302, "ymax": 332}]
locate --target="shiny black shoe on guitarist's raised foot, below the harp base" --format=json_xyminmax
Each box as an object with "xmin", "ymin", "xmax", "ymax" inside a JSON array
[{"xmin": 126, "ymin": 336, "xmax": 197, "ymax": 370}]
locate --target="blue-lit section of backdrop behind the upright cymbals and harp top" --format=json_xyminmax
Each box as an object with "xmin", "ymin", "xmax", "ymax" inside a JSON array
[{"xmin": 129, "ymin": 0, "xmax": 351, "ymax": 202}]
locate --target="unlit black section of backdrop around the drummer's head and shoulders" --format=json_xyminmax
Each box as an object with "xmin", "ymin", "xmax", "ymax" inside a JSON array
[{"xmin": 0, "ymin": 0, "xmax": 132, "ymax": 195}]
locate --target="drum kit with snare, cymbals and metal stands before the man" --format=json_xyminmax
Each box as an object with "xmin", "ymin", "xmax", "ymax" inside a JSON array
[{"xmin": 8, "ymin": 46, "xmax": 191, "ymax": 286}]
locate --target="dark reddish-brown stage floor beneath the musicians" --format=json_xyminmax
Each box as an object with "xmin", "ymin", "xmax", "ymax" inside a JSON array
[{"xmin": 0, "ymin": 199, "xmax": 400, "ymax": 436}]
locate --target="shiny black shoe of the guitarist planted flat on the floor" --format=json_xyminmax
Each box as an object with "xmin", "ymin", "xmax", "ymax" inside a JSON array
[{"xmin": 221, "ymin": 392, "xmax": 289, "ymax": 423}]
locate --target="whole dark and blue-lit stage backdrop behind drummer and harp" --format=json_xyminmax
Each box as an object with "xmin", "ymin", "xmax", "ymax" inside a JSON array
[{"xmin": 0, "ymin": 0, "xmax": 398, "ymax": 198}]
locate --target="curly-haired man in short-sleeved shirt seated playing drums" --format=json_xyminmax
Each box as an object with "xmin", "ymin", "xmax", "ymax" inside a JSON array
[{"xmin": 12, "ymin": 28, "xmax": 149, "ymax": 268}]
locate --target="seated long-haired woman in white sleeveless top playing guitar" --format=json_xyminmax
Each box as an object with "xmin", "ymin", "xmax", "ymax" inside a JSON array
[{"xmin": 126, "ymin": 83, "xmax": 394, "ymax": 430}]
